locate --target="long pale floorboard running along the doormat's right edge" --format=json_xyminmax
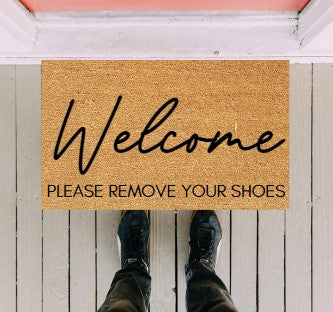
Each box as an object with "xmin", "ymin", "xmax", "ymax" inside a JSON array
[{"xmin": 286, "ymin": 64, "xmax": 312, "ymax": 312}]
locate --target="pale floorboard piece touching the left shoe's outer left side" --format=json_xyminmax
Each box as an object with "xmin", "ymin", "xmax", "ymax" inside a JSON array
[{"xmin": 96, "ymin": 210, "xmax": 121, "ymax": 307}]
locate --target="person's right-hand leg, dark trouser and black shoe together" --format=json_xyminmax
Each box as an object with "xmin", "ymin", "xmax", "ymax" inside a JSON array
[{"xmin": 185, "ymin": 210, "xmax": 238, "ymax": 312}]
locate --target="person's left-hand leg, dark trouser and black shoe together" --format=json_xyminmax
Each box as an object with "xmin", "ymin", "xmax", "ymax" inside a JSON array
[{"xmin": 98, "ymin": 210, "xmax": 151, "ymax": 312}]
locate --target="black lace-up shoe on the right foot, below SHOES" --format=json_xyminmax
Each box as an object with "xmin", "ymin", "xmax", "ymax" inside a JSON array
[{"xmin": 188, "ymin": 210, "xmax": 222, "ymax": 269}]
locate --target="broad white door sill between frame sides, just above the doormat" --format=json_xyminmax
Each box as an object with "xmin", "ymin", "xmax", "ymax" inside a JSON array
[{"xmin": 28, "ymin": 14, "xmax": 299, "ymax": 59}]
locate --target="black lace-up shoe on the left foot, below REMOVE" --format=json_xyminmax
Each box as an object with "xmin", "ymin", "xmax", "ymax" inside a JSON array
[{"xmin": 118, "ymin": 210, "xmax": 149, "ymax": 271}]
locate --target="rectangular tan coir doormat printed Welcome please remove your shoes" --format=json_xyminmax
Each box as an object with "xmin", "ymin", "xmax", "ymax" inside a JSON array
[{"xmin": 41, "ymin": 61, "xmax": 289, "ymax": 210}]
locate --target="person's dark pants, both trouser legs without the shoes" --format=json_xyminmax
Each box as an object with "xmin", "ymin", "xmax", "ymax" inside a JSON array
[{"xmin": 98, "ymin": 263, "xmax": 238, "ymax": 312}]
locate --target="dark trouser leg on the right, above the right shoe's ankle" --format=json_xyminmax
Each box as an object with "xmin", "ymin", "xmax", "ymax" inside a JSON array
[{"xmin": 185, "ymin": 262, "xmax": 238, "ymax": 312}]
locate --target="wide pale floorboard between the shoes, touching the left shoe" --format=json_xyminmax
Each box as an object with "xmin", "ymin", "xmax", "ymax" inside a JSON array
[{"xmin": 150, "ymin": 211, "xmax": 176, "ymax": 312}]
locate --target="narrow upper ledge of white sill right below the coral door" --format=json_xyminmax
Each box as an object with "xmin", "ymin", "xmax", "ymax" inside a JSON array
[{"xmin": 35, "ymin": 11, "xmax": 298, "ymax": 29}]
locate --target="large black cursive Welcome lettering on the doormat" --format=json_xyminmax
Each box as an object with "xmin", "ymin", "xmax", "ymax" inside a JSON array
[{"xmin": 53, "ymin": 96, "xmax": 285, "ymax": 175}]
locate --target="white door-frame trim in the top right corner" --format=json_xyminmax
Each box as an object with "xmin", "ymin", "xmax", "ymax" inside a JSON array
[{"xmin": 298, "ymin": 0, "xmax": 333, "ymax": 47}]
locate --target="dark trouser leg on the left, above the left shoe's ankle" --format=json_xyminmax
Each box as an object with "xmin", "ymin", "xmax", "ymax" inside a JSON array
[{"xmin": 98, "ymin": 268, "xmax": 151, "ymax": 312}]
